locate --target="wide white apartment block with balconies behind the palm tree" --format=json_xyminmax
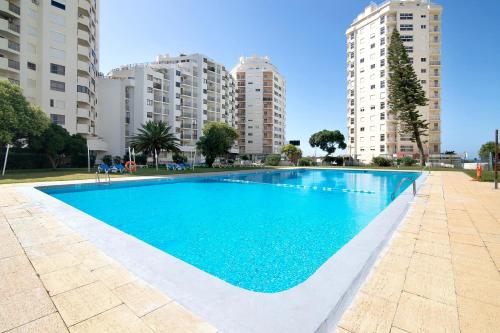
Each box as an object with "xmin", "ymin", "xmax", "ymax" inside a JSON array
[{"xmin": 98, "ymin": 54, "xmax": 237, "ymax": 161}]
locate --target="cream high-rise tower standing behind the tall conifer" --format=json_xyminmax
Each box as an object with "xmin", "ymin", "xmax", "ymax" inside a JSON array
[{"xmin": 346, "ymin": 0, "xmax": 442, "ymax": 163}]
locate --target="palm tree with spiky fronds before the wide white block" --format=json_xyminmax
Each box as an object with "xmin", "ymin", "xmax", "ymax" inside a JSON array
[{"xmin": 130, "ymin": 120, "xmax": 180, "ymax": 164}]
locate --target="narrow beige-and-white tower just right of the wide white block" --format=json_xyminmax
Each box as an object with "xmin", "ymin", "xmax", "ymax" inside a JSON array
[{"xmin": 231, "ymin": 56, "xmax": 286, "ymax": 159}]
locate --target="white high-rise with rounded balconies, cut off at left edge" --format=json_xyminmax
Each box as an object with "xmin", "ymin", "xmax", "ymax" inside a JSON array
[{"xmin": 0, "ymin": 0, "xmax": 106, "ymax": 150}]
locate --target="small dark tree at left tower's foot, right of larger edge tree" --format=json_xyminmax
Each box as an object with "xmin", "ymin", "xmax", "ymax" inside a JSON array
[{"xmin": 28, "ymin": 124, "xmax": 71, "ymax": 169}]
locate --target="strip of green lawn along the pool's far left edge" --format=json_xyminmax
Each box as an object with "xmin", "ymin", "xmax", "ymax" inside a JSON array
[{"xmin": 0, "ymin": 167, "xmax": 266, "ymax": 184}]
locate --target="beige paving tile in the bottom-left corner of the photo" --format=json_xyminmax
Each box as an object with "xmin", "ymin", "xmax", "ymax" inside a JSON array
[{"xmin": 0, "ymin": 288, "xmax": 56, "ymax": 332}]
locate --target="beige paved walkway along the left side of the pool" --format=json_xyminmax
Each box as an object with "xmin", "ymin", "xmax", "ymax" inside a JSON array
[{"xmin": 0, "ymin": 186, "xmax": 216, "ymax": 333}]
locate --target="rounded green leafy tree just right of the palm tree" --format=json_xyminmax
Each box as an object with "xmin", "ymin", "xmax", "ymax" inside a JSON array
[{"xmin": 196, "ymin": 122, "xmax": 238, "ymax": 167}]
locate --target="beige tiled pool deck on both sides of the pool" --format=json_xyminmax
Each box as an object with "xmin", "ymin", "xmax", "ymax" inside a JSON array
[{"xmin": 0, "ymin": 172, "xmax": 500, "ymax": 333}]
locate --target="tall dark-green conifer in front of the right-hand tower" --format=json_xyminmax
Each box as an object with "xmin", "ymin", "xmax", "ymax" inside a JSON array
[{"xmin": 387, "ymin": 30, "xmax": 429, "ymax": 165}]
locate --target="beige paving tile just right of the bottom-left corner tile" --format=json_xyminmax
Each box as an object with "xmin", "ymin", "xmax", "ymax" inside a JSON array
[{"xmin": 52, "ymin": 282, "xmax": 122, "ymax": 326}]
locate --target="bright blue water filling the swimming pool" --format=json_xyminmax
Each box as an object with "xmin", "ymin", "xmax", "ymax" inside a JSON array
[{"xmin": 40, "ymin": 170, "xmax": 419, "ymax": 293}]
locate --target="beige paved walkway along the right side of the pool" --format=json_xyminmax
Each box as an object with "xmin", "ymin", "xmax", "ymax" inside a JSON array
[{"xmin": 337, "ymin": 172, "xmax": 500, "ymax": 333}]
